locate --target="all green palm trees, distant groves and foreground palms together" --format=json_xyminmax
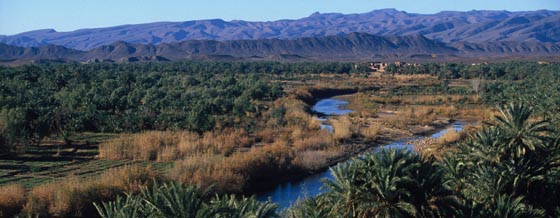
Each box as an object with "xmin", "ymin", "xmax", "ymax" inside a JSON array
[{"xmin": 0, "ymin": 62, "xmax": 560, "ymax": 217}]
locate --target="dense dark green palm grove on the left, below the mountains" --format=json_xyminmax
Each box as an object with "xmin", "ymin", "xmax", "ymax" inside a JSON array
[{"xmin": 0, "ymin": 61, "xmax": 282, "ymax": 150}]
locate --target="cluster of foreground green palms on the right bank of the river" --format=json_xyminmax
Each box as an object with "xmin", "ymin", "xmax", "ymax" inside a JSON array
[{"xmin": 289, "ymin": 103, "xmax": 560, "ymax": 217}]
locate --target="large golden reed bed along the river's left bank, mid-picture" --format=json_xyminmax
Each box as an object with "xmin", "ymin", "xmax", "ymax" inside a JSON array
[{"xmin": 99, "ymin": 98, "xmax": 353, "ymax": 193}]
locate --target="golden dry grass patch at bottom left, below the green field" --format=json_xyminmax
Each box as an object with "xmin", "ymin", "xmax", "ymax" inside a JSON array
[{"xmin": 23, "ymin": 166, "xmax": 156, "ymax": 217}]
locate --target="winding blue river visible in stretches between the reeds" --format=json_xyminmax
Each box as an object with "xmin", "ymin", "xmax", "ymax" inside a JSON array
[{"xmin": 257, "ymin": 98, "xmax": 463, "ymax": 210}]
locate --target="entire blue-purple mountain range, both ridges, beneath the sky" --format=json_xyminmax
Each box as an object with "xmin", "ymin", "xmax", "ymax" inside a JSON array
[{"xmin": 0, "ymin": 9, "xmax": 560, "ymax": 62}]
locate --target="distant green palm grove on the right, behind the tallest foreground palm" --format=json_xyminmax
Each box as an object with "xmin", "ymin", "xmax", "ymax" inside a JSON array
[{"xmin": 395, "ymin": 61, "xmax": 560, "ymax": 119}]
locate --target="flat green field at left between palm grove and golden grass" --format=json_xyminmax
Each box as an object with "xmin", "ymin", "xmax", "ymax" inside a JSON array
[{"xmin": 0, "ymin": 133, "xmax": 172, "ymax": 189}]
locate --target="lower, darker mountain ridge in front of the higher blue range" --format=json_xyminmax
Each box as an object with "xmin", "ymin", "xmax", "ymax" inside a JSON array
[{"xmin": 0, "ymin": 33, "xmax": 560, "ymax": 64}]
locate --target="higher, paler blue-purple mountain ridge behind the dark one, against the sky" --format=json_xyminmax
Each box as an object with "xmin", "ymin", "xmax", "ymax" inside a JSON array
[{"xmin": 0, "ymin": 9, "xmax": 560, "ymax": 51}]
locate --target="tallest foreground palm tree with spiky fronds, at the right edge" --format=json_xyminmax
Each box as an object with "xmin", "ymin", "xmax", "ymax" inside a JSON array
[{"xmin": 450, "ymin": 103, "xmax": 560, "ymax": 217}]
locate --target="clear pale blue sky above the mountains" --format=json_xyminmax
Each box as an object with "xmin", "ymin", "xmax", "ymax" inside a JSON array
[{"xmin": 0, "ymin": 0, "xmax": 560, "ymax": 35}]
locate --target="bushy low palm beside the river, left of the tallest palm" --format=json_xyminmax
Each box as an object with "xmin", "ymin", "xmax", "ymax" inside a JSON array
[{"xmin": 324, "ymin": 150, "xmax": 420, "ymax": 217}]
